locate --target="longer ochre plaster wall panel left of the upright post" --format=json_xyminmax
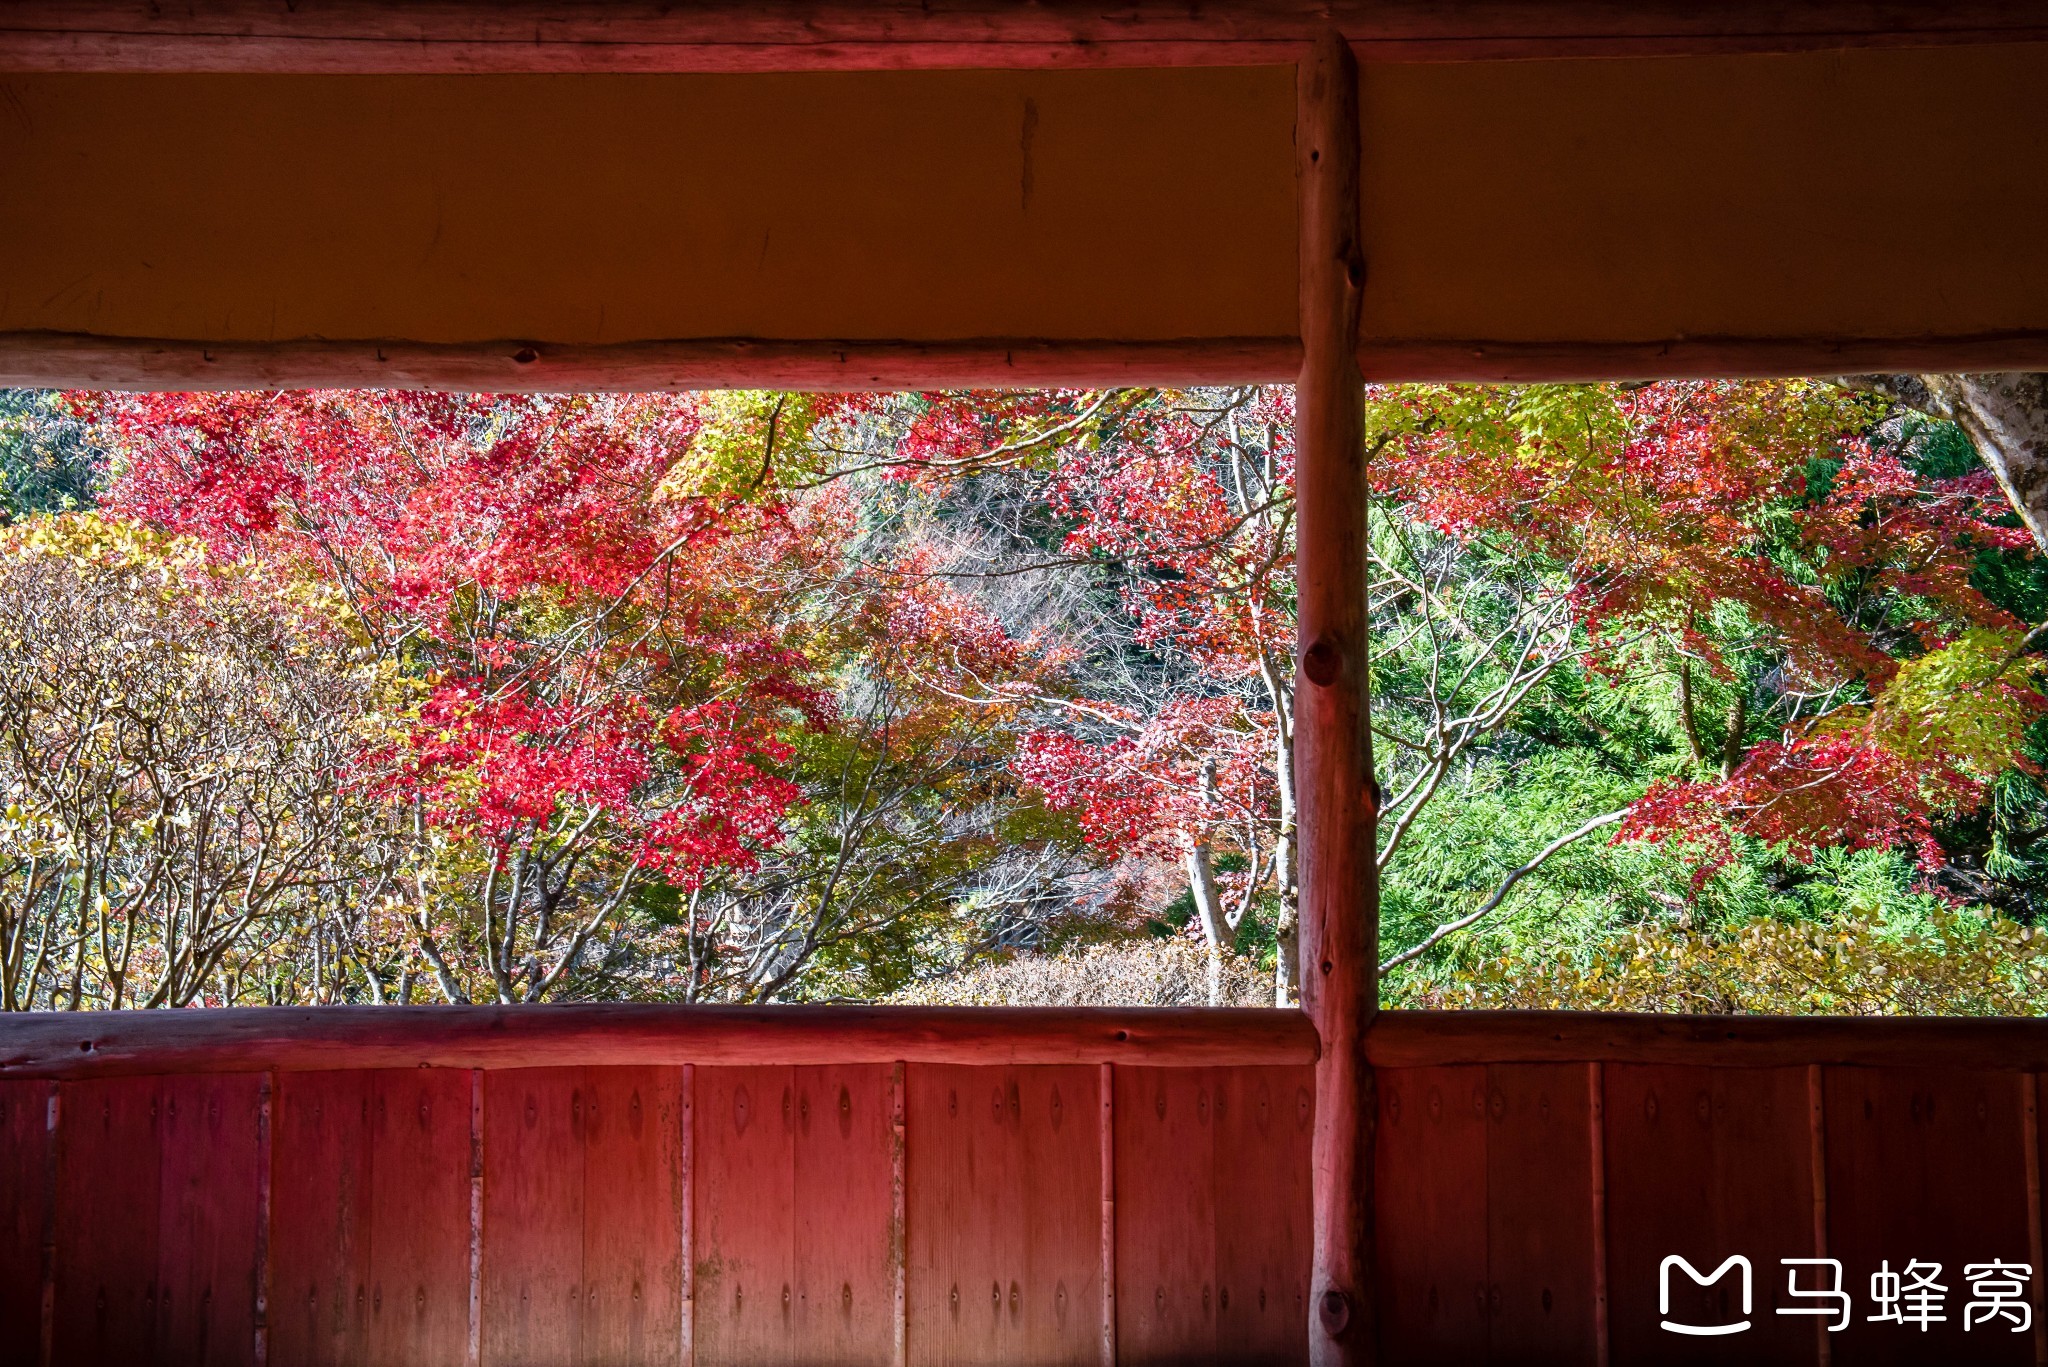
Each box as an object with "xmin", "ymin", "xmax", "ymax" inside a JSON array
[{"xmin": 0, "ymin": 68, "xmax": 1296, "ymax": 342}]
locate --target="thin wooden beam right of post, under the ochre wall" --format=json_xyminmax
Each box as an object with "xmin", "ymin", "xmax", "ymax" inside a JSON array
[{"xmin": 1358, "ymin": 330, "xmax": 2048, "ymax": 383}]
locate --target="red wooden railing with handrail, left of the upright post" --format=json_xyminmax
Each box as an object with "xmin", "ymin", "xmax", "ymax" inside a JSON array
[{"xmin": 0, "ymin": 1006, "xmax": 1317, "ymax": 1365}]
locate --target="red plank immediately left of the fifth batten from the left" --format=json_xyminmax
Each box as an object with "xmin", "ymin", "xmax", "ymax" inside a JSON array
[{"xmin": 788, "ymin": 1066, "xmax": 895, "ymax": 1367}]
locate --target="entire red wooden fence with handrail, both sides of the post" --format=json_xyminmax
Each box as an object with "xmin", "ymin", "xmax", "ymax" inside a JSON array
[{"xmin": 0, "ymin": 1006, "xmax": 2048, "ymax": 1365}]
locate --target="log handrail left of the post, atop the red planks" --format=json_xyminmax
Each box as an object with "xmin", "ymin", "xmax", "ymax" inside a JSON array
[{"xmin": 0, "ymin": 1004, "xmax": 1317, "ymax": 1078}]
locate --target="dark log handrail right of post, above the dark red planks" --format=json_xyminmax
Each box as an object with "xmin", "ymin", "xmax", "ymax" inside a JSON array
[{"xmin": 1366, "ymin": 1010, "xmax": 2048, "ymax": 1072}]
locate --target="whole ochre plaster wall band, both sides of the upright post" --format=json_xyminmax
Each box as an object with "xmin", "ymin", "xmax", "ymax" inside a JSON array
[{"xmin": 12, "ymin": 45, "xmax": 2048, "ymax": 344}]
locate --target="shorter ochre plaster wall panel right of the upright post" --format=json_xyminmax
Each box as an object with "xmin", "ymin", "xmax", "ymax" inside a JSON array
[{"xmin": 1360, "ymin": 45, "xmax": 2048, "ymax": 342}]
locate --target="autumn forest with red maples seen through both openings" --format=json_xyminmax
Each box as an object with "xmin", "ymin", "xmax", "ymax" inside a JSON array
[{"xmin": 0, "ymin": 381, "xmax": 2048, "ymax": 1014}]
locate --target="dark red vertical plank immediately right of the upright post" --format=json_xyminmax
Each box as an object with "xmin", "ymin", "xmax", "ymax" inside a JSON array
[{"xmin": 1368, "ymin": 1066, "xmax": 1487, "ymax": 1367}]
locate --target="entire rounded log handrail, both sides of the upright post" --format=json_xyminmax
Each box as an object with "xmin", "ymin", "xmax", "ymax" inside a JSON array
[{"xmin": 24, "ymin": 1004, "xmax": 2048, "ymax": 1078}]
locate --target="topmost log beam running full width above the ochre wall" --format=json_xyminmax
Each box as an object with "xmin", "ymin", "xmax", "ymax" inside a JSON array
[{"xmin": 0, "ymin": 0, "xmax": 2048, "ymax": 72}]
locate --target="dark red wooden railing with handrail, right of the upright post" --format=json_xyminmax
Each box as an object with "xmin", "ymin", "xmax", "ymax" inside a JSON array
[{"xmin": 1368, "ymin": 1012, "xmax": 2048, "ymax": 1367}]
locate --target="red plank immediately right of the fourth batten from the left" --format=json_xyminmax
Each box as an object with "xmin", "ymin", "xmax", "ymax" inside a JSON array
[{"xmin": 692, "ymin": 1068, "xmax": 797, "ymax": 1367}]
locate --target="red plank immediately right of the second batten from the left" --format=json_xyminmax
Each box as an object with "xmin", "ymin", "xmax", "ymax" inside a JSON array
[{"xmin": 270, "ymin": 1072, "xmax": 375, "ymax": 1367}]
